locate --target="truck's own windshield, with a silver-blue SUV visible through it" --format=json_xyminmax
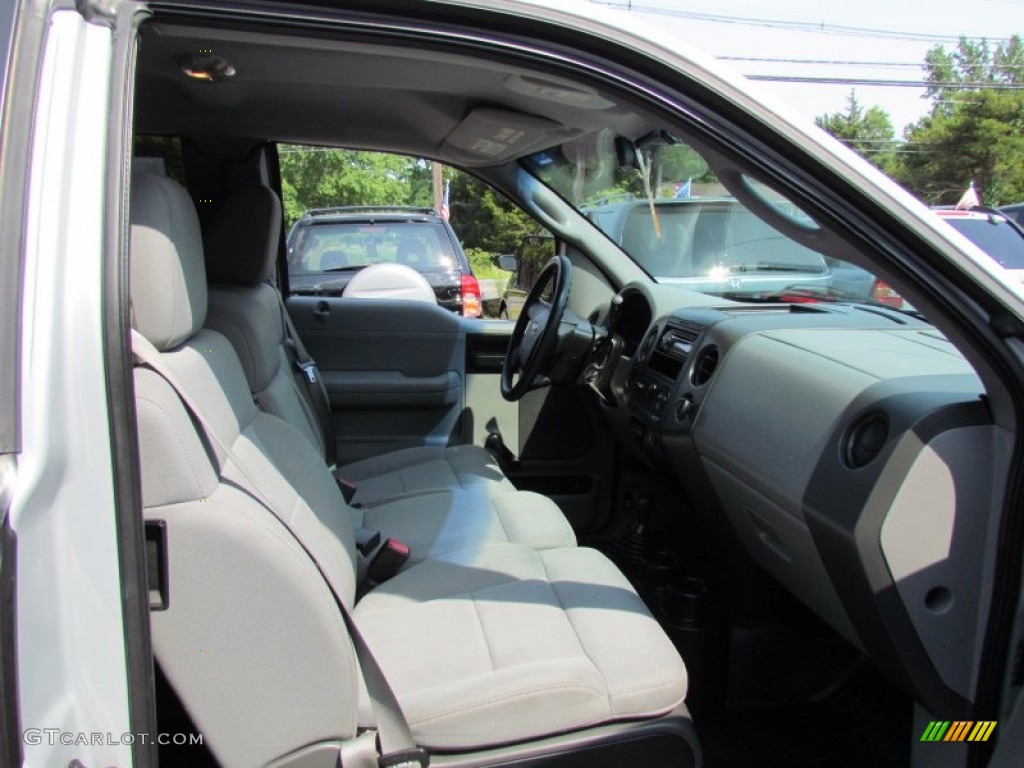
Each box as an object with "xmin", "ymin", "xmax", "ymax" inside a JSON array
[{"xmin": 525, "ymin": 133, "xmax": 896, "ymax": 306}]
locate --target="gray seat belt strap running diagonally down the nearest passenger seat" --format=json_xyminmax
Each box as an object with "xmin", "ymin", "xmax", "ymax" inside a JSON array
[{"xmin": 131, "ymin": 329, "xmax": 430, "ymax": 768}]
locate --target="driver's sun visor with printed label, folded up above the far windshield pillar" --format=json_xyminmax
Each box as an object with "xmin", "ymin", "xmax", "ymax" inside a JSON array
[{"xmin": 441, "ymin": 106, "xmax": 577, "ymax": 166}]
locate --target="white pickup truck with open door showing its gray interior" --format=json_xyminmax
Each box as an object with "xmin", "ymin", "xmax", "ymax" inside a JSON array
[{"xmin": 0, "ymin": 0, "xmax": 1024, "ymax": 768}]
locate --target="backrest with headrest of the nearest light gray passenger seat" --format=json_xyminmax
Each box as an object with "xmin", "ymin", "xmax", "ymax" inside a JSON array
[{"xmin": 131, "ymin": 174, "xmax": 359, "ymax": 766}]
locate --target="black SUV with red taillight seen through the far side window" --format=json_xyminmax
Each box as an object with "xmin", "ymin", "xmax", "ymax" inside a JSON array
[{"xmin": 288, "ymin": 207, "xmax": 480, "ymax": 317}]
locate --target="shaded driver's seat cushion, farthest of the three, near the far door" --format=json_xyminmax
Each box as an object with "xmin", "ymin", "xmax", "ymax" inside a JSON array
[{"xmin": 337, "ymin": 445, "xmax": 515, "ymax": 506}]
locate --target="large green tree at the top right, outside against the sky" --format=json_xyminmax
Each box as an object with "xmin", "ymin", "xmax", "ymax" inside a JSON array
[{"xmin": 893, "ymin": 35, "xmax": 1024, "ymax": 205}]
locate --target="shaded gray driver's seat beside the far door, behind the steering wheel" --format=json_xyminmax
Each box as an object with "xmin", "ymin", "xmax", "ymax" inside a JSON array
[{"xmin": 205, "ymin": 186, "xmax": 515, "ymax": 512}]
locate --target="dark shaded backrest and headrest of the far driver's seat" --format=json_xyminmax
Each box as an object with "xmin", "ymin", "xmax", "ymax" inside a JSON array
[{"xmin": 204, "ymin": 186, "xmax": 326, "ymax": 457}]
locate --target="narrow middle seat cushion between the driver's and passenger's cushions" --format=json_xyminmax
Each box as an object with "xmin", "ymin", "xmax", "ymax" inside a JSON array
[{"xmin": 356, "ymin": 490, "xmax": 575, "ymax": 564}]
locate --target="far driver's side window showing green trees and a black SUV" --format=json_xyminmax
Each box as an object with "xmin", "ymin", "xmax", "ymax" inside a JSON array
[{"xmin": 279, "ymin": 144, "xmax": 553, "ymax": 318}]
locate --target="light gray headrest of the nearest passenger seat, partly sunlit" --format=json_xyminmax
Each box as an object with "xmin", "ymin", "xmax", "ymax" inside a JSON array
[{"xmin": 131, "ymin": 173, "xmax": 206, "ymax": 351}]
